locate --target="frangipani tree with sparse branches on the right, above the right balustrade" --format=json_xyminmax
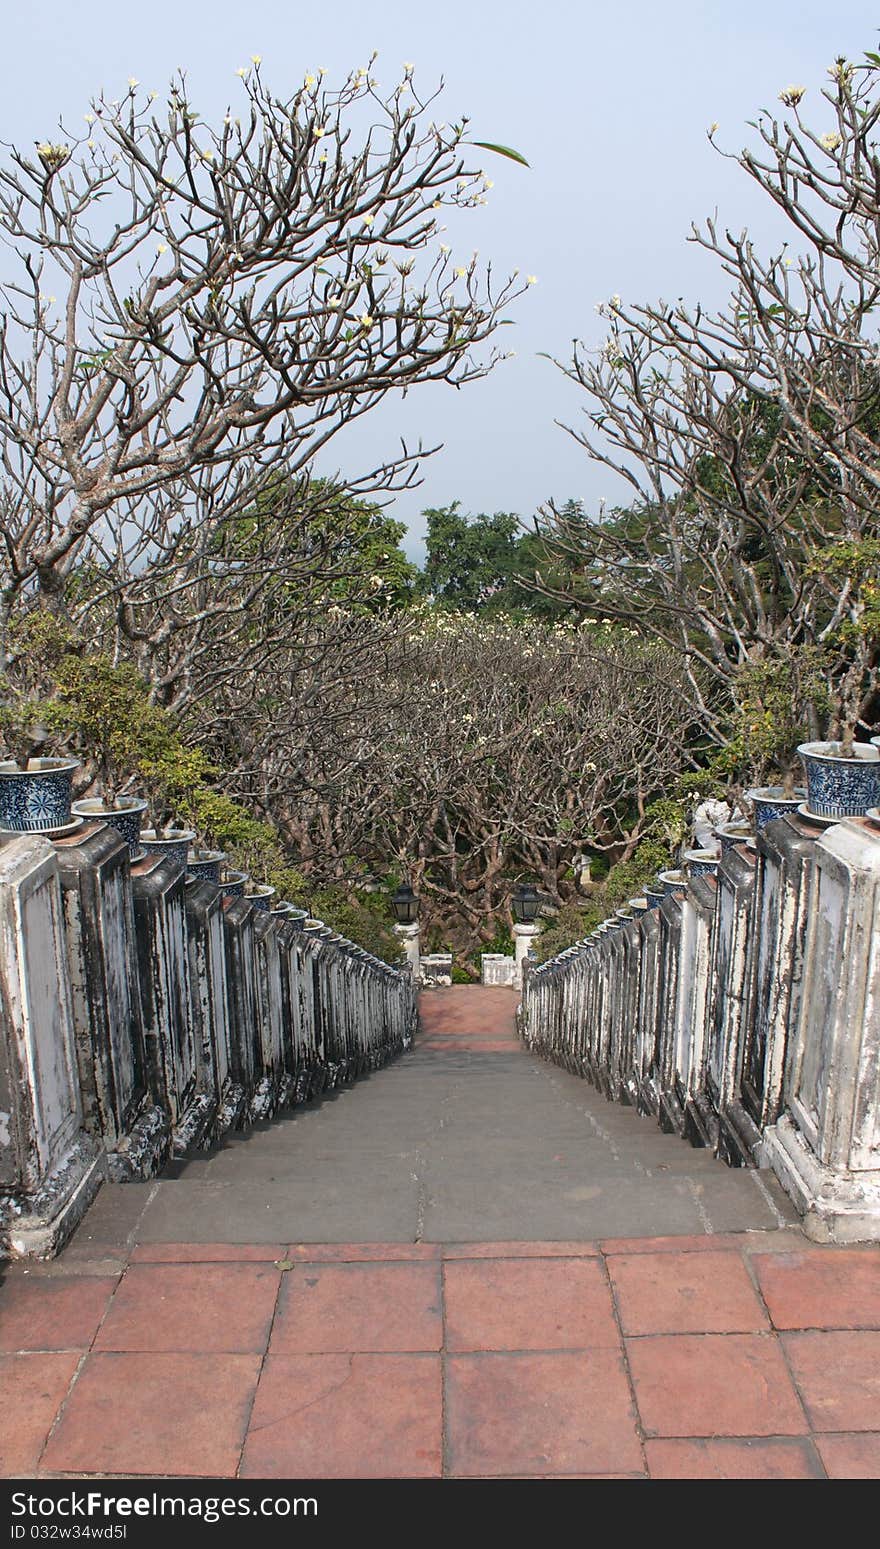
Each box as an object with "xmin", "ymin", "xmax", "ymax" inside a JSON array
[{"xmin": 532, "ymin": 54, "xmax": 880, "ymax": 745}]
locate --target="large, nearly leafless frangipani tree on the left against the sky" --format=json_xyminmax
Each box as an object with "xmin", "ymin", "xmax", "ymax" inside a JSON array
[{"xmin": 0, "ymin": 60, "xmax": 522, "ymax": 647}]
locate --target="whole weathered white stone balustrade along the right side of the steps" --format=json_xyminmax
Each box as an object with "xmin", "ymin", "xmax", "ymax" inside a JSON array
[{"xmin": 517, "ymin": 818, "xmax": 880, "ymax": 1241}]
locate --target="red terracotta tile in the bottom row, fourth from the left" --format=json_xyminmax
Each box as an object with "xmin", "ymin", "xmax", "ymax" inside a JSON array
[{"xmin": 446, "ymin": 1349, "xmax": 643, "ymax": 1478}]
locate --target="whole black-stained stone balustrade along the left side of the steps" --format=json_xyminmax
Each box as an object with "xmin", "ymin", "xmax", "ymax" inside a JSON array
[{"xmin": 0, "ymin": 824, "xmax": 418, "ymax": 1256}]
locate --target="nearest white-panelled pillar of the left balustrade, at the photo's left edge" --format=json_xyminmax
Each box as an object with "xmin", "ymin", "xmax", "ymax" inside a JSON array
[{"xmin": 0, "ymin": 835, "xmax": 104, "ymax": 1258}]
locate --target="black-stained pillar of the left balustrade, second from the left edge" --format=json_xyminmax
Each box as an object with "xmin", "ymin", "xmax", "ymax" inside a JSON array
[{"xmin": 56, "ymin": 824, "xmax": 170, "ymax": 1182}]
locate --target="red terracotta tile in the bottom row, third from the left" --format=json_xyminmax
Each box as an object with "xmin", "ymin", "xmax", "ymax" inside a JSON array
[{"xmin": 242, "ymin": 1354, "xmax": 443, "ymax": 1479}]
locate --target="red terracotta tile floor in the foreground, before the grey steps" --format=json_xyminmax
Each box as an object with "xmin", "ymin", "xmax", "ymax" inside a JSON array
[{"xmin": 0, "ymin": 1231, "xmax": 880, "ymax": 1479}]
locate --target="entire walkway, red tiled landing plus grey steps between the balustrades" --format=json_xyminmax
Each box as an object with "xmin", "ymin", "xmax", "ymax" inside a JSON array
[{"xmin": 0, "ymin": 988, "xmax": 880, "ymax": 1479}]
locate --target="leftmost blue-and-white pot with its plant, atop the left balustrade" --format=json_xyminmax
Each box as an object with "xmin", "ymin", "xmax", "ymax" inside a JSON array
[{"xmin": 0, "ymin": 685, "xmax": 79, "ymax": 833}]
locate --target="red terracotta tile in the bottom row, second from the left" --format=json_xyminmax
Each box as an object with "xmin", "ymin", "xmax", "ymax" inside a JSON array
[{"xmin": 42, "ymin": 1352, "xmax": 260, "ymax": 1479}]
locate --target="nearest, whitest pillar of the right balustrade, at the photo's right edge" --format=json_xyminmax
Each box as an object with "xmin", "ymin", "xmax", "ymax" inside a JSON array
[{"xmin": 762, "ymin": 818, "xmax": 880, "ymax": 1242}]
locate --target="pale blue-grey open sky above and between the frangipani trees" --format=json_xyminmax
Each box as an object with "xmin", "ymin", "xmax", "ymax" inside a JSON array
[{"xmin": 0, "ymin": 0, "xmax": 880, "ymax": 559}]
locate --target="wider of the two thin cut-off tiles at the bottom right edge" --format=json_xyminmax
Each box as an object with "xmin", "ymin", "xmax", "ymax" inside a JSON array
[{"xmin": 645, "ymin": 1436, "xmax": 824, "ymax": 1479}]
